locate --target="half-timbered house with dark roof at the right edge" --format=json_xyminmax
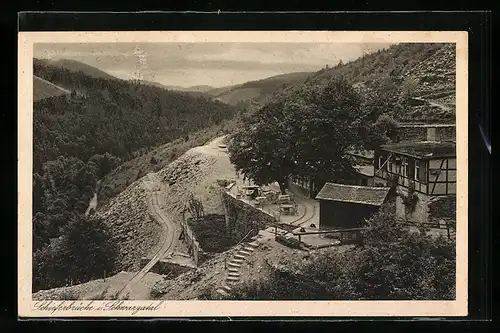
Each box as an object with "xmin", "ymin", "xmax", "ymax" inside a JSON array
[{"xmin": 374, "ymin": 142, "xmax": 457, "ymax": 223}]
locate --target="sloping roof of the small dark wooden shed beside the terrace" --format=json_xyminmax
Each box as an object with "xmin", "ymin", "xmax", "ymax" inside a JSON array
[{"xmin": 316, "ymin": 183, "xmax": 390, "ymax": 206}]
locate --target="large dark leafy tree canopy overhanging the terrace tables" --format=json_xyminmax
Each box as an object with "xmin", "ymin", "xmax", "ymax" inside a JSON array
[{"xmin": 229, "ymin": 77, "xmax": 391, "ymax": 191}]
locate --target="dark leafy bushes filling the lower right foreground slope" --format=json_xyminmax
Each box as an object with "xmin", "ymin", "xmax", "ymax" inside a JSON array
[{"xmin": 232, "ymin": 207, "xmax": 456, "ymax": 300}]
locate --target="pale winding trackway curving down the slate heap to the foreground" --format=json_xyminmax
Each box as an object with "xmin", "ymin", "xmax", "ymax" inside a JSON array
[{"xmin": 117, "ymin": 173, "xmax": 177, "ymax": 299}]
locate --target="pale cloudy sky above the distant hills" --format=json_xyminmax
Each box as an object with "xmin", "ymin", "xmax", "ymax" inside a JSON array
[{"xmin": 34, "ymin": 43, "xmax": 390, "ymax": 87}]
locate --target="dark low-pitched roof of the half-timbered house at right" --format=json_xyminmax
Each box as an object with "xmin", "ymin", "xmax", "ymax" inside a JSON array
[{"xmin": 381, "ymin": 142, "xmax": 457, "ymax": 159}]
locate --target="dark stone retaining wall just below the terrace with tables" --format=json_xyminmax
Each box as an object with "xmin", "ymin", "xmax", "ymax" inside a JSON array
[{"xmin": 221, "ymin": 192, "xmax": 277, "ymax": 242}]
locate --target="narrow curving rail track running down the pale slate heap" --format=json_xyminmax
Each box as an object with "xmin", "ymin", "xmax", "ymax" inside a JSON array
[{"xmin": 117, "ymin": 176, "xmax": 176, "ymax": 299}]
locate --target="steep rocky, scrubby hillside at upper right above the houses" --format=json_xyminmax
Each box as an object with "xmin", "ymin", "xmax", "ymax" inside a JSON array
[{"xmin": 306, "ymin": 43, "xmax": 455, "ymax": 123}]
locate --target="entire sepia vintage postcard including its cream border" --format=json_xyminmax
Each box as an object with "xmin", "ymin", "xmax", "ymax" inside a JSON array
[{"xmin": 18, "ymin": 31, "xmax": 468, "ymax": 318}]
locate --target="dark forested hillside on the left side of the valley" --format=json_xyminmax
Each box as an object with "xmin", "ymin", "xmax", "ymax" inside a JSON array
[{"xmin": 33, "ymin": 62, "xmax": 240, "ymax": 289}]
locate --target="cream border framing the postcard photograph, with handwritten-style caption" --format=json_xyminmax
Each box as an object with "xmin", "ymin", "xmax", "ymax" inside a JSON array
[{"xmin": 18, "ymin": 31, "xmax": 468, "ymax": 317}]
